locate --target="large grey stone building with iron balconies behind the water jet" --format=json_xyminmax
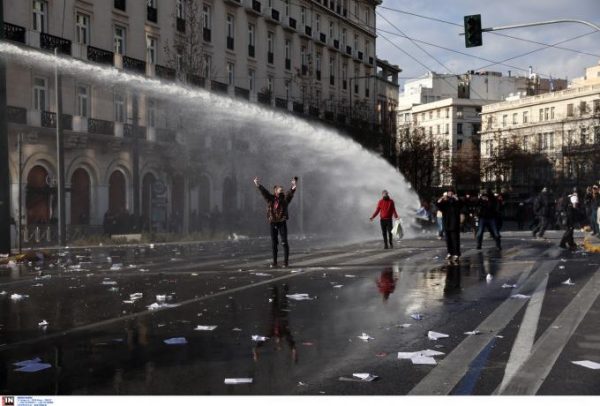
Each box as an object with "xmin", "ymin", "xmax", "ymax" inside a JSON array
[{"xmin": 4, "ymin": 0, "xmax": 391, "ymax": 244}]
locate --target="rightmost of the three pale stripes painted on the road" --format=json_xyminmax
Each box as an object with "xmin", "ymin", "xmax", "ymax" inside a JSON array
[{"xmin": 500, "ymin": 268, "xmax": 600, "ymax": 395}]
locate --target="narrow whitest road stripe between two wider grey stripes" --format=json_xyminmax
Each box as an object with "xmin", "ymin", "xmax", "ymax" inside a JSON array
[{"xmin": 496, "ymin": 275, "xmax": 548, "ymax": 392}]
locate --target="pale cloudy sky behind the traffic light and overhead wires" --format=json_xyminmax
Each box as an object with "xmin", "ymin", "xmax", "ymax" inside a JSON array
[{"xmin": 376, "ymin": 0, "xmax": 600, "ymax": 89}]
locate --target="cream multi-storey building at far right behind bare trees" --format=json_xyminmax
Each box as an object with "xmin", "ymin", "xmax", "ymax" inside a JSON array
[{"xmin": 481, "ymin": 64, "xmax": 600, "ymax": 193}]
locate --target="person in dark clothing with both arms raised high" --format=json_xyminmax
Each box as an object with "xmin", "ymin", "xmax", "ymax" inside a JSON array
[{"xmin": 254, "ymin": 177, "xmax": 298, "ymax": 268}]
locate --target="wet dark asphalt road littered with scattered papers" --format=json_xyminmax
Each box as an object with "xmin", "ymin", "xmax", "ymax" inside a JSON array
[{"xmin": 0, "ymin": 232, "xmax": 600, "ymax": 395}]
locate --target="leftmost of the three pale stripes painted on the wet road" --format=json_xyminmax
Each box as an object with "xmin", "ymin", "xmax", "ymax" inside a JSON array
[{"xmin": 408, "ymin": 261, "xmax": 558, "ymax": 395}]
